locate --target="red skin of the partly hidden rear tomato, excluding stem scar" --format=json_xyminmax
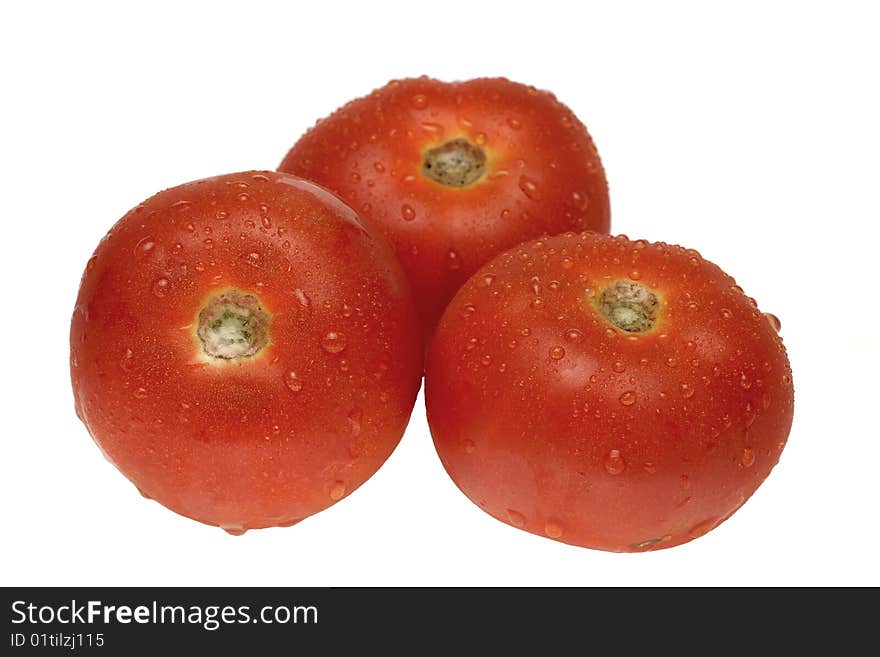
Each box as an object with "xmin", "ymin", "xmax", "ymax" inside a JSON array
[{"xmin": 280, "ymin": 77, "xmax": 610, "ymax": 335}]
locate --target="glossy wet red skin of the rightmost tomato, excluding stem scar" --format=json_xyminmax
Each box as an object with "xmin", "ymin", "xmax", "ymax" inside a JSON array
[{"xmin": 425, "ymin": 233, "xmax": 793, "ymax": 551}]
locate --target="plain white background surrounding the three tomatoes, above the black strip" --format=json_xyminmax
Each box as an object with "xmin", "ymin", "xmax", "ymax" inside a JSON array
[{"xmin": 0, "ymin": 0, "xmax": 880, "ymax": 586}]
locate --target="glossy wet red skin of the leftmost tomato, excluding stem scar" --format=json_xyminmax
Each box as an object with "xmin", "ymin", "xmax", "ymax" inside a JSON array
[{"xmin": 70, "ymin": 172, "xmax": 422, "ymax": 533}]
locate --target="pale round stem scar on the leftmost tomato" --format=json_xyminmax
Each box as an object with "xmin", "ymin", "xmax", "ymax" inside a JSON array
[{"xmin": 198, "ymin": 290, "xmax": 271, "ymax": 360}]
